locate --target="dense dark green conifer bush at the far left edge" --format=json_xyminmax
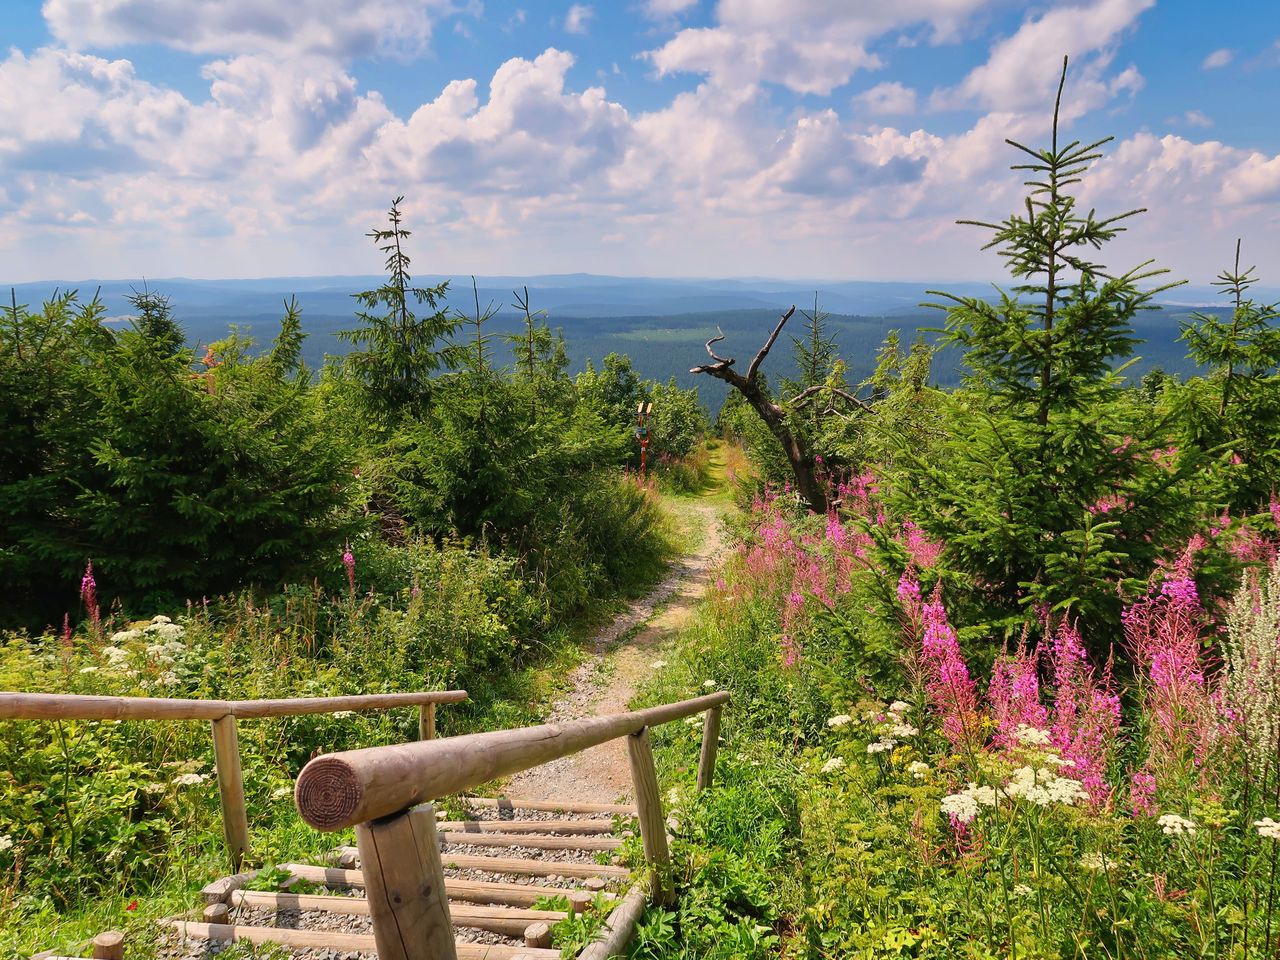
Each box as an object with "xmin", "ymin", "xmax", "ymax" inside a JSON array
[{"xmin": 0, "ymin": 293, "xmax": 352, "ymax": 625}]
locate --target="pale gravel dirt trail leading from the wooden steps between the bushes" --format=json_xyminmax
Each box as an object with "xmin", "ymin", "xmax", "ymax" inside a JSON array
[{"xmin": 506, "ymin": 502, "xmax": 724, "ymax": 803}]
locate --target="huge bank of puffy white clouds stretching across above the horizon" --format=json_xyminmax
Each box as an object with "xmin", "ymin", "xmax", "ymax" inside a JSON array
[{"xmin": 0, "ymin": 22, "xmax": 1280, "ymax": 285}]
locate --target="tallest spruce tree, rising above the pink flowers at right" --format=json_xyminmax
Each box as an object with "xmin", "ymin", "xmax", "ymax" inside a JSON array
[{"xmin": 897, "ymin": 59, "xmax": 1204, "ymax": 626}]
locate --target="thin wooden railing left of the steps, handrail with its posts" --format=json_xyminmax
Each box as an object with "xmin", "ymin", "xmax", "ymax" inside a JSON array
[{"xmin": 0, "ymin": 690, "xmax": 467, "ymax": 870}]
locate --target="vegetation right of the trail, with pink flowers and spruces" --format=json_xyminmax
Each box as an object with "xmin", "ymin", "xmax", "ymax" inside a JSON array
[{"xmin": 635, "ymin": 64, "xmax": 1280, "ymax": 960}]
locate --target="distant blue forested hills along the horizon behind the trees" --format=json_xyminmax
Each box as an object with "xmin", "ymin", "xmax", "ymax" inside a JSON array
[{"xmin": 5, "ymin": 274, "xmax": 1254, "ymax": 411}]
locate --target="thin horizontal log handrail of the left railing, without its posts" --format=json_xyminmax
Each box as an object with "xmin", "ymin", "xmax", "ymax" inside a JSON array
[{"xmin": 0, "ymin": 690, "xmax": 467, "ymax": 721}]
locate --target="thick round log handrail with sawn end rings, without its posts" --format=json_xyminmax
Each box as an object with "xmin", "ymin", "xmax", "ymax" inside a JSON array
[{"xmin": 293, "ymin": 691, "xmax": 728, "ymax": 831}]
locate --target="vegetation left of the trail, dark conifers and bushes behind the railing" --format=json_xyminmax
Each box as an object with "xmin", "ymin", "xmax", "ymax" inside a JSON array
[{"xmin": 0, "ymin": 195, "xmax": 705, "ymax": 955}]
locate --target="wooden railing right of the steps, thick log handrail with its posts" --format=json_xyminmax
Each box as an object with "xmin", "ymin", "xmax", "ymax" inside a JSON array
[{"xmin": 293, "ymin": 692, "xmax": 728, "ymax": 960}]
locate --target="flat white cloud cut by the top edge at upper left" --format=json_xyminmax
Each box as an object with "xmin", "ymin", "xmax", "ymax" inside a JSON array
[{"xmin": 44, "ymin": 0, "xmax": 454, "ymax": 59}]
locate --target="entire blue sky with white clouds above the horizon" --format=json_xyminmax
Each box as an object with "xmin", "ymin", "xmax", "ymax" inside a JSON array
[{"xmin": 0, "ymin": 0, "xmax": 1280, "ymax": 284}]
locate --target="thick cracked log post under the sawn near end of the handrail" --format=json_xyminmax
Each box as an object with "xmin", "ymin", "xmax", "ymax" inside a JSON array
[{"xmin": 356, "ymin": 804, "xmax": 457, "ymax": 960}]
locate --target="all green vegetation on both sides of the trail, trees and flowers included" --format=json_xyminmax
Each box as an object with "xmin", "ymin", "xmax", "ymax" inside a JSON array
[{"xmin": 0, "ymin": 60, "xmax": 1280, "ymax": 960}]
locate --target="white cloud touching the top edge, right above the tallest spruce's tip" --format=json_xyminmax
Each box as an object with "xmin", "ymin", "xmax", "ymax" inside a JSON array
[{"xmin": 933, "ymin": 0, "xmax": 1156, "ymax": 115}]
